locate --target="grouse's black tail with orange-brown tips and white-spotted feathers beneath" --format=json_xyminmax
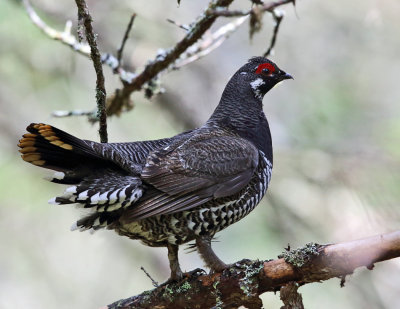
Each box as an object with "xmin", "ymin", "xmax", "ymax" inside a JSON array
[{"xmin": 18, "ymin": 123, "xmax": 143, "ymax": 230}]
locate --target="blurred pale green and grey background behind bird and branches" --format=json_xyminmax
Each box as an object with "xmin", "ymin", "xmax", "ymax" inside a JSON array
[{"xmin": 0, "ymin": 0, "xmax": 400, "ymax": 308}]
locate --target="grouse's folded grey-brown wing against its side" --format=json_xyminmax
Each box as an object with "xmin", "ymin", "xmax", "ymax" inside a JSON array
[{"xmin": 124, "ymin": 136, "xmax": 258, "ymax": 222}]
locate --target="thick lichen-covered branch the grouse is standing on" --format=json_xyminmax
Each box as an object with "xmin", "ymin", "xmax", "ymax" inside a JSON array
[{"xmin": 108, "ymin": 231, "xmax": 400, "ymax": 309}]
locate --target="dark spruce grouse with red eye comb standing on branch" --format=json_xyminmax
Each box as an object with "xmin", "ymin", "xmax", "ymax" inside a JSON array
[{"xmin": 18, "ymin": 57, "xmax": 292, "ymax": 280}]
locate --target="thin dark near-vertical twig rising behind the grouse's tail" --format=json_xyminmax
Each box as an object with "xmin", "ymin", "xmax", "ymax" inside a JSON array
[{"xmin": 75, "ymin": 0, "xmax": 108, "ymax": 143}]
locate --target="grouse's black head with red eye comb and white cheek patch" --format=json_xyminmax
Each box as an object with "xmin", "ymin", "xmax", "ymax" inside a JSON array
[{"xmin": 234, "ymin": 57, "xmax": 293, "ymax": 100}]
